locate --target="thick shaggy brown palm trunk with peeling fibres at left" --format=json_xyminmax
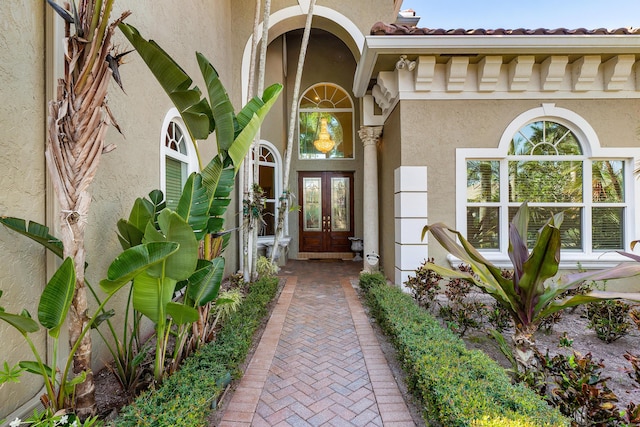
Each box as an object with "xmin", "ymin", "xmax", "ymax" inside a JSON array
[{"xmin": 45, "ymin": 0, "xmax": 130, "ymax": 419}]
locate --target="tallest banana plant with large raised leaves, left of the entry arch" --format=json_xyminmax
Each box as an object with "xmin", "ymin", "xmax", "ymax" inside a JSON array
[{"xmin": 118, "ymin": 23, "xmax": 282, "ymax": 260}]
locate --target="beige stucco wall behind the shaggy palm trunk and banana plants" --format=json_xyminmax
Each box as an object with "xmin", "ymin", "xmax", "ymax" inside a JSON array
[{"xmin": 0, "ymin": 0, "xmax": 237, "ymax": 419}]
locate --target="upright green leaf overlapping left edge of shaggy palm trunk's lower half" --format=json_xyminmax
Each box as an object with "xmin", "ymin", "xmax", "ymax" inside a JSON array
[{"xmin": 38, "ymin": 258, "xmax": 76, "ymax": 338}]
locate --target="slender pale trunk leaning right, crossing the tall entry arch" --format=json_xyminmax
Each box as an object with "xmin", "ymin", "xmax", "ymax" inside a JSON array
[{"xmin": 271, "ymin": 0, "xmax": 316, "ymax": 263}]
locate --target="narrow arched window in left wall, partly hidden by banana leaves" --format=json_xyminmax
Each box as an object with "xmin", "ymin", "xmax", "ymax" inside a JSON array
[{"xmin": 160, "ymin": 108, "xmax": 198, "ymax": 209}]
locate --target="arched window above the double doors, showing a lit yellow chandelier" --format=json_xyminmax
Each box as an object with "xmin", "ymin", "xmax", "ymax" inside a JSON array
[{"xmin": 298, "ymin": 83, "xmax": 354, "ymax": 160}]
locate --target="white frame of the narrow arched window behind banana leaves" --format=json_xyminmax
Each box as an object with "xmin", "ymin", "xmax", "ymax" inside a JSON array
[{"xmin": 160, "ymin": 108, "xmax": 200, "ymax": 209}]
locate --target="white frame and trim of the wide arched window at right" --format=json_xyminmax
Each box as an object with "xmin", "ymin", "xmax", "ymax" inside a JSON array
[{"xmin": 456, "ymin": 104, "xmax": 640, "ymax": 269}]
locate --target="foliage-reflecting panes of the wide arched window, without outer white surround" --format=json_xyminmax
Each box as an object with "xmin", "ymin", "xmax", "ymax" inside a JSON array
[{"xmin": 466, "ymin": 120, "xmax": 626, "ymax": 252}]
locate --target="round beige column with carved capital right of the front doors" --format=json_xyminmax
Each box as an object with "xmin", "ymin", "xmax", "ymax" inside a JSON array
[{"xmin": 358, "ymin": 126, "xmax": 382, "ymax": 272}]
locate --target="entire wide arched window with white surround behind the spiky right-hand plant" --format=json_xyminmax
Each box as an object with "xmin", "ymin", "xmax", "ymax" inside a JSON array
[{"xmin": 456, "ymin": 104, "xmax": 640, "ymax": 268}]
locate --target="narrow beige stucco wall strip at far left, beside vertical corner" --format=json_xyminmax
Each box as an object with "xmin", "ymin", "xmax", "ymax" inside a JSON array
[{"xmin": 0, "ymin": 0, "xmax": 46, "ymax": 419}]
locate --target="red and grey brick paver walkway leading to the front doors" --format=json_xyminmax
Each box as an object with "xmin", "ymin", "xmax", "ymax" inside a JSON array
[{"xmin": 220, "ymin": 261, "xmax": 414, "ymax": 427}]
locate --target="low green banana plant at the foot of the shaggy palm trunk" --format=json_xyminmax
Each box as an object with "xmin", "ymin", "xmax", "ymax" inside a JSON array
[{"xmin": 0, "ymin": 244, "xmax": 179, "ymax": 414}]
